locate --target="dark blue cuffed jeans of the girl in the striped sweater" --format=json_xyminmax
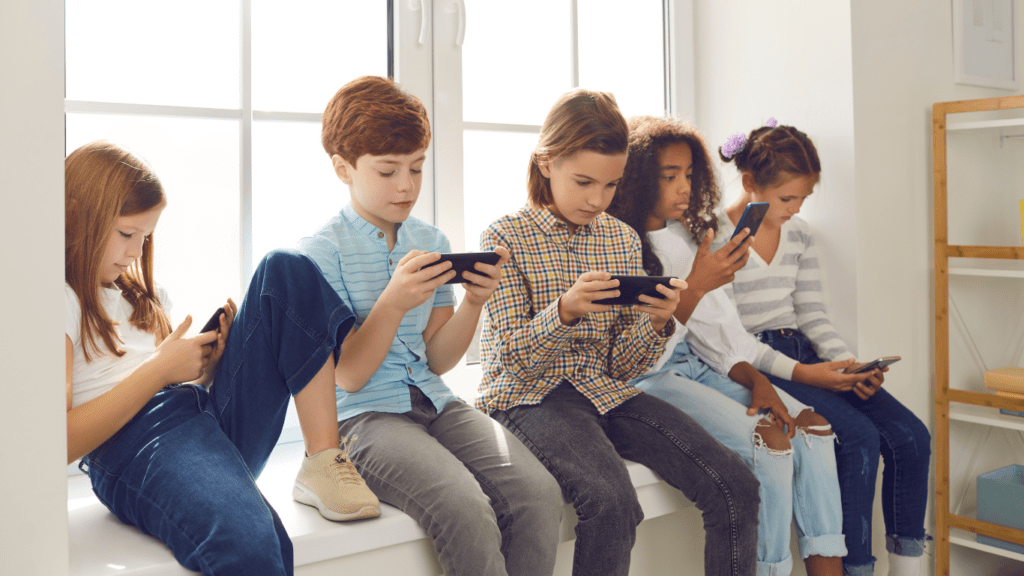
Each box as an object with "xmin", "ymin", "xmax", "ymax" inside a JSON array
[{"xmin": 757, "ymin": 329, "xmax": 932, "ymax": 576}]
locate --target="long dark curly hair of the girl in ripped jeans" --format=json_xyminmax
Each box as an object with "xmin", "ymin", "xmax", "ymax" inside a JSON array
[{"xmin": 606, "ymin": 116, "xmax": 722, "ymax": 276}]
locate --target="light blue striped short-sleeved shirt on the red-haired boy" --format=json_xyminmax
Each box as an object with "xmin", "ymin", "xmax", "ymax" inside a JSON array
[{"xmin": 299, "ymin": 204, "xmax": 457, "ymax": 420}]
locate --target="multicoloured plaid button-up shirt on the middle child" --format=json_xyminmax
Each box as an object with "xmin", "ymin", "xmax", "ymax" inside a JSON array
[{"xmin": 477, "ymin": 206, "xmax": 676, "ymax": 414}]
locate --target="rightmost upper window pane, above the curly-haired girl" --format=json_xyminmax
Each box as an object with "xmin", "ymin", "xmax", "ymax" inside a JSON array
[{"xmin": 579, "ymin": 0, "xmax": 666, "ymax": 118}]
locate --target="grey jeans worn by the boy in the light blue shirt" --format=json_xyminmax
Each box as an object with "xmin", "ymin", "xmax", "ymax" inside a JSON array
[{"xmin": 338, "ymin": 386, "xmax": 564, "ymax": 576}]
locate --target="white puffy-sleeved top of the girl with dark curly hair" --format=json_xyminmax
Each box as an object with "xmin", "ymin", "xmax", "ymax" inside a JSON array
[{"xmin": 647, "ymin": 220, "xmax": 797, "ymax": 379}]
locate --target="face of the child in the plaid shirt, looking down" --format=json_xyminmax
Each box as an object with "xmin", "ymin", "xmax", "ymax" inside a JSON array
[{"xmin": 540, "ymin": 150, "xmax": 626, "ymax": 232}]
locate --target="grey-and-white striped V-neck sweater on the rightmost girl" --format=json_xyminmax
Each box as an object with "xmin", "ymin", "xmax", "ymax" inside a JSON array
[{"xmin": 712, "ymin": 210, "xmax": 853, "ymax": 363}]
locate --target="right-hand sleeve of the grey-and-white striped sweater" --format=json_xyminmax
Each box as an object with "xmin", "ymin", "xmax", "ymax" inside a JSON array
[{"xmin": 788, "ymin": 225, "xmax": 853, "ymax": 361}]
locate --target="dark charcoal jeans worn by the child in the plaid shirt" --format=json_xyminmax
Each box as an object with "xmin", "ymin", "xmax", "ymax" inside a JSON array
[{"xmin": 492, "ymin": 381, "xmax": 759, "ymax": 576}]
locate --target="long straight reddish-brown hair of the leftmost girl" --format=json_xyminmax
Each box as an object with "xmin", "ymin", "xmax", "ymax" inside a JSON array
[{"xmin": 65, "ymin": 140, "xmax": 171, "ymax": 361}]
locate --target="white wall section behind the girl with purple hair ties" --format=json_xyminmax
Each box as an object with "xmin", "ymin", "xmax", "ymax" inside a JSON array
[{"xmin": 694, "ymin": 0, "xmax": 864, "ymax": 354}]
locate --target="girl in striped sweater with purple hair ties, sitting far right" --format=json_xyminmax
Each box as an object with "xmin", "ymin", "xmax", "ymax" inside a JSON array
[{"xmin": 719, "ymin": 120, "xmax": 931, "ymax": 576}]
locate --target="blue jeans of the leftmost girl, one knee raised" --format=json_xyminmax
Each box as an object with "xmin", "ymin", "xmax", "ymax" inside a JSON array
[{"xmin": 82, "ymin": 252, "xmax": 353, "ymax": 576}]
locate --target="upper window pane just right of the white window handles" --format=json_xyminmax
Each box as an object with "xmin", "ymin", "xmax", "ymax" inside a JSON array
[{"xmin": 462, "ymin": 0, "xmax": 572, "ymax": 125}]
